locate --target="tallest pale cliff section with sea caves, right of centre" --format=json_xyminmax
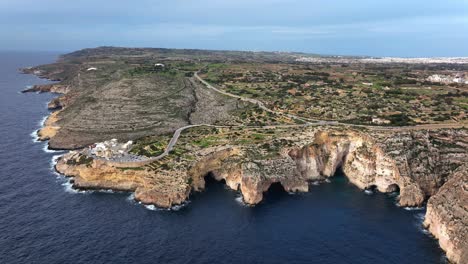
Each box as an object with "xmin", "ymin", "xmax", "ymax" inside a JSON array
[{"xmin": 290, "ymin": 132, "xmax": 424, "ymax": 206}]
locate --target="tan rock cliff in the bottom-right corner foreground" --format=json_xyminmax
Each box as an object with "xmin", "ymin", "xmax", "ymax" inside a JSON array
[{"xmin": 424, "ymin": 165, "xmax": 468, "ymax": 263}]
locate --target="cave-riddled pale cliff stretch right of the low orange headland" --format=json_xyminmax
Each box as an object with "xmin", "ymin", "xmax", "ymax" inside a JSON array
[{"xmin": 188, "ymin": 131, "xmax": 424, "ymax": 206}]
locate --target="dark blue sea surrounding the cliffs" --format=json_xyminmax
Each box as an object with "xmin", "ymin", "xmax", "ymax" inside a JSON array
[{"xmin": 0, "ymin": 52, "xmax": 445, "ymax": 264}]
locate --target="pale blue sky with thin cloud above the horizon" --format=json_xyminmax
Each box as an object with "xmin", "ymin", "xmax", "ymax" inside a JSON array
[{"xmin": 0, "ymin": 0, "xmax": 468, "ymax": 57}]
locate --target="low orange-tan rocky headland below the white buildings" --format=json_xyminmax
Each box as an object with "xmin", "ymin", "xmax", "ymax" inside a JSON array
[{"xmin": 55, "ymin": 151, "xmax": 190, "ymax": 208}]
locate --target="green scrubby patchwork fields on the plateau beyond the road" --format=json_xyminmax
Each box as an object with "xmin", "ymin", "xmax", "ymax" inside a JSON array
[{"xmin": 201, "ymin": 62, "xmax": 468, "ymax": 126}]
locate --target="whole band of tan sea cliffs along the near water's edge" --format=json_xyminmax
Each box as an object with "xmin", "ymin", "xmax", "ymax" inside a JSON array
[{"xmin": 49, "ymin": 128, "xmax": 468, "ymax": 263}]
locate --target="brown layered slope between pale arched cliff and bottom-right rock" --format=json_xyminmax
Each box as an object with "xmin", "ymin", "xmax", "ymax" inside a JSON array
[{"xmin": 371, "ymin": 129, "xmax": 468, "ymax": 198}]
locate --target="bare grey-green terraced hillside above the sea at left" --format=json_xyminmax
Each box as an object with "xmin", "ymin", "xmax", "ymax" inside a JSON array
[{"xmin": 23, "ymin": 58, "xmax": 247, "ymax": 149}]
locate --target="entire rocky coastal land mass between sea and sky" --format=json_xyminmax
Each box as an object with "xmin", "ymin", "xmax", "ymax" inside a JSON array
[{"xmin": 22, "ymin": 47, "xmax": 468, "ymax": 263}]
